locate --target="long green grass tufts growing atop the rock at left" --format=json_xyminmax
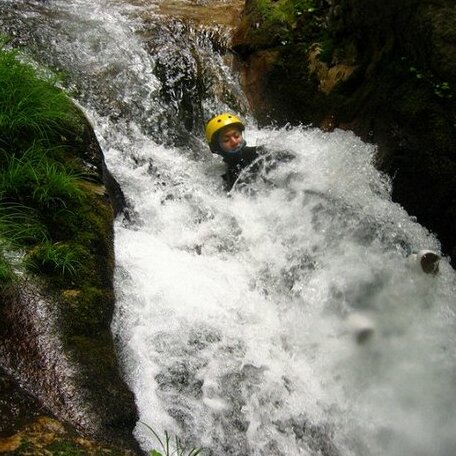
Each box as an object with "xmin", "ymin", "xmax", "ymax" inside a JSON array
[{"xmin": 0, "ymin": 40, "xmax": 88, "ymax": 288}]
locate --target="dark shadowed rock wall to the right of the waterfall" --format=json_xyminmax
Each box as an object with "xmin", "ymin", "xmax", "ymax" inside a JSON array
[{"xmin": 233, "ymin": 0, "xmax": 456, "ymax": 264}]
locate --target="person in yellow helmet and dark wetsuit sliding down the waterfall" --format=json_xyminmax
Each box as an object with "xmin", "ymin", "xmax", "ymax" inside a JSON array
[{"xmin": 205, "ymin": 112, "xmax": 262, "ymax": 191}]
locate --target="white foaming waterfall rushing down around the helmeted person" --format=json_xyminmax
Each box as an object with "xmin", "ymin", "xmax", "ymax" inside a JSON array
[{"xmin": 0, "ymin": 0, "xmax": 456, "ymax": 456}]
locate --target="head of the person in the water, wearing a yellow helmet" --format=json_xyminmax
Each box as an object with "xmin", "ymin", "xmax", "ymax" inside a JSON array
[{"xmin": 206, "ymin": 112, "xmax": 245, "ymax": 153}]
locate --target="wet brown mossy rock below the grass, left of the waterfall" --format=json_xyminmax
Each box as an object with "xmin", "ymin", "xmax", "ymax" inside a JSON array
[{"xmin": 0, "ymin": 114, "xmax": 140, "ymax": 454}]
